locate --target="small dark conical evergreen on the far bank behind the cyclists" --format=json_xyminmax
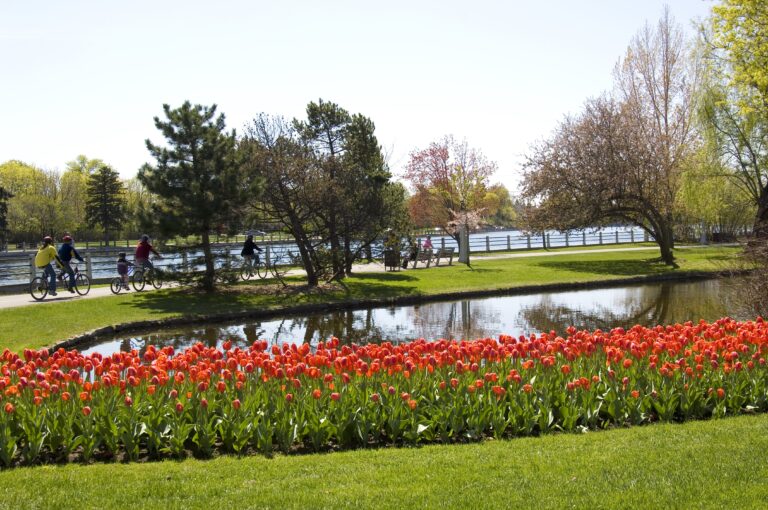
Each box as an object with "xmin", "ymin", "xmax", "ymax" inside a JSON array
[{"xmin": 85, "ymin": 164, "xmax": 125, "ymax": 243}]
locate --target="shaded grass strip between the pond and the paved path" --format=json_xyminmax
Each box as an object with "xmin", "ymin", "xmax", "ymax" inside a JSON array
[{"xmin": 0, "ymin": 247, "xmax": 740, "ymax": 351}]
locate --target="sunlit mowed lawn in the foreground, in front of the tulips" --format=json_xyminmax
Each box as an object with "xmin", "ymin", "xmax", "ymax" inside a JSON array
[{"xmin": 0, "ymin": 415, "xmax": 768, "ymax": 509}]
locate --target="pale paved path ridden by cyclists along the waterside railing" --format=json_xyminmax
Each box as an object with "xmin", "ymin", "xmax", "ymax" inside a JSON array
[{"xmin": 0, "ymin": 246, "xmax": 686, "ymax": 309}]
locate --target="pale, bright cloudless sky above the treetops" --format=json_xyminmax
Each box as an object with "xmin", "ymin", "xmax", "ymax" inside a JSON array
[{"xmin": 0, "ymin": 0, "xmax": 713, "ymax": 192}]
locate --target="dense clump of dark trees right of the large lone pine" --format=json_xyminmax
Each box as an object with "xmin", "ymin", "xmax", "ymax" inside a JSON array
[{"xmin": 242, "ymin": 100, "xmax": 406, "ymax": 286}]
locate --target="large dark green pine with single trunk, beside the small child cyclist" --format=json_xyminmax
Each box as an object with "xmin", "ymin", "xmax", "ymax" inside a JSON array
[{"xmin": 138, "ymin": 101, "xmax": 253, "ymax": 290}]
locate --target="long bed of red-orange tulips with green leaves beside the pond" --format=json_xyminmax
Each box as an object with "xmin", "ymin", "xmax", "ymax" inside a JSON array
[{"xmin": 0, "ymin": 318, "xmax": 768, "ymax": 467}]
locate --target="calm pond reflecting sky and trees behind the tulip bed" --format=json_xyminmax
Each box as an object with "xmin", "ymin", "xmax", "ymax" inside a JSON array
[{"xmin": 83, "ymin": 279, "xmax": 739, "ymax": 354}]
